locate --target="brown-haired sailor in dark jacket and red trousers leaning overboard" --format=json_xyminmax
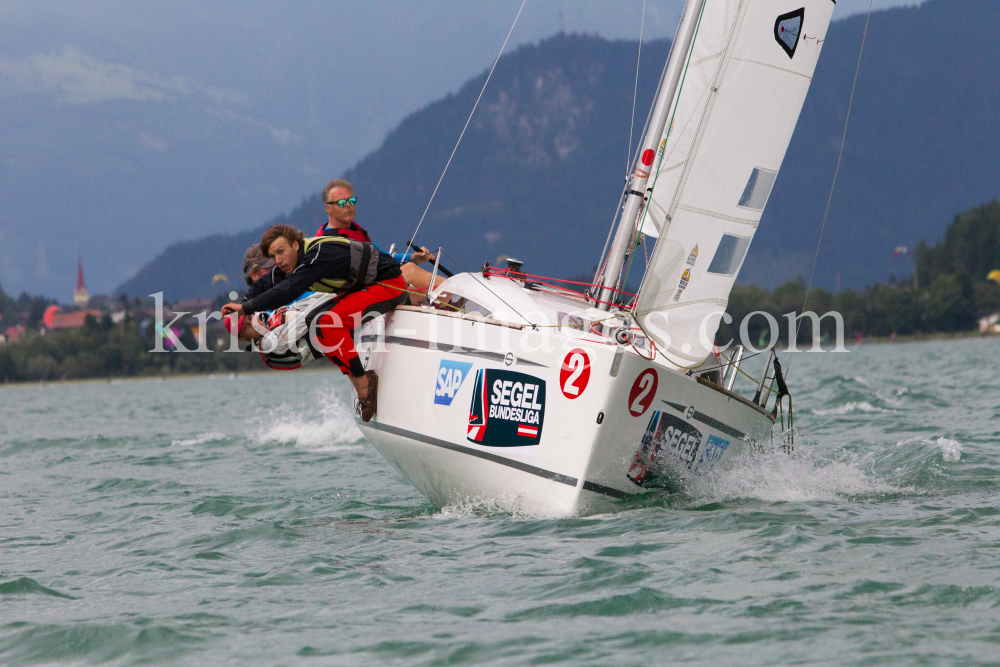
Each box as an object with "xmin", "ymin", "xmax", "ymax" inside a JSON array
[{"xmin": 222, "ymin": 225, "xmax": 406, "ymax": 421}]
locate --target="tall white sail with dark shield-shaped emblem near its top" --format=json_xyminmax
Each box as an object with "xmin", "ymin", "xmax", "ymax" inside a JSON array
[{"xmin": 636, "ymin": 0, "xmax": 834, "ymax": 367}]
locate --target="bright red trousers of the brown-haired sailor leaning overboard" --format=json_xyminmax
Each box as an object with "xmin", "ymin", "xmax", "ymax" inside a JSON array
[{"xmin": 316, "ymin": 276, "xmax": 407, "ymax": 377}]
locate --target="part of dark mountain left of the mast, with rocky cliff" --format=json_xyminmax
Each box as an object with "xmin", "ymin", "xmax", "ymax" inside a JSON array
[{"xmin": 121, "ymin": 35, "xmax": 669, "ymax": 299}]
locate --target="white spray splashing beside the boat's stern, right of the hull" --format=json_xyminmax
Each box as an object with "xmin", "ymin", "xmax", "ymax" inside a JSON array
[{"xmin": 687, "ymin": 452, "xmax": 902, "ymax": 503}]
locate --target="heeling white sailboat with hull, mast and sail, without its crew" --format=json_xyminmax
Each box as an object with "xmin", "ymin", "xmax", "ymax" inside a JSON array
[{"xmin": 358, "ymin": 0, "xmax": 835, "ymax": 516}]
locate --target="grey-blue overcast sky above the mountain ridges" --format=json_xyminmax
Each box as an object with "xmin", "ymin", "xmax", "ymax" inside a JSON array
[{"xmin": 0, "ymin": 0, "xmax": 916, "ymax": 183}]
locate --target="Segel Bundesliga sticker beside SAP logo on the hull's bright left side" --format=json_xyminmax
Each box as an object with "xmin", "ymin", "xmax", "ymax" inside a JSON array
[{"xmin": 468, "ymin": 368, "xmax": 545, "ymax": 447}]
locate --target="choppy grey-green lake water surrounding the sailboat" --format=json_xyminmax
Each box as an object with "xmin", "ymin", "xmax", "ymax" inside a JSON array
[{"xmin": 0, "ymin": 339, "xmax": 1000, "ymax": 665}]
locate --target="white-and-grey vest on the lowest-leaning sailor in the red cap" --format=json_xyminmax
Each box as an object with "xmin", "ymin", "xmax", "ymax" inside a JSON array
[{"xmin": 253, "ymin": 292, "xmax": 337, "ymax": 371}]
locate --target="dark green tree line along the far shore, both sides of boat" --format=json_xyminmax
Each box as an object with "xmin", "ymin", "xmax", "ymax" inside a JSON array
[{"xmin": 0, "ymin": 201, "xmax": 1000, "ymax": 382}]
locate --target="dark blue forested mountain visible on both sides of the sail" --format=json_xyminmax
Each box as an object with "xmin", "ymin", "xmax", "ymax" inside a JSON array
[{"xmin": 115, "ymin": 0, "xmax": 1000, "ymax": 296}]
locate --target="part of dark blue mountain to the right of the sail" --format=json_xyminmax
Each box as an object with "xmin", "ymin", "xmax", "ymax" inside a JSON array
[{"xmin": 741, "ymin": 0, "xmax": 1000, "ymax": 287}]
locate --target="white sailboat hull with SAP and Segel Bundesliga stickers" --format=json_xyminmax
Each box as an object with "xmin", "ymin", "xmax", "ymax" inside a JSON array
[{"xmin": 358, "ymin": 298, "xmax": 773, "ymax": 516}]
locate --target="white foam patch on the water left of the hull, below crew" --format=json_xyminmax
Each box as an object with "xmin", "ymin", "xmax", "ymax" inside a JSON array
[{"xmin": 250, "ymin": 390, "xmax": 364, "ymax": 452}]
